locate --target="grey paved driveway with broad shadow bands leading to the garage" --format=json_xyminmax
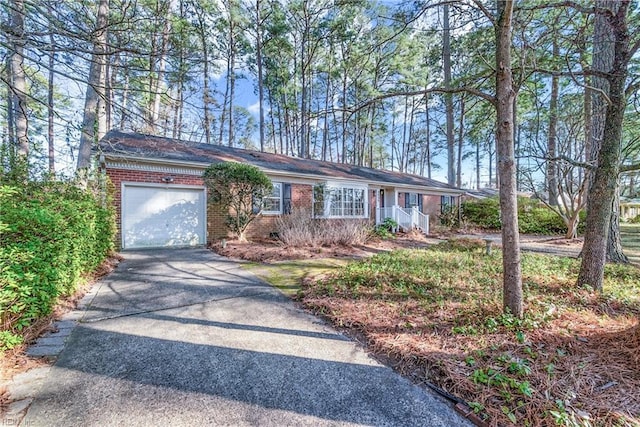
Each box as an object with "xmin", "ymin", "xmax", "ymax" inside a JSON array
[{"xmin": 22, "ymin": 249, "xmax": 471, "ymax": 427}]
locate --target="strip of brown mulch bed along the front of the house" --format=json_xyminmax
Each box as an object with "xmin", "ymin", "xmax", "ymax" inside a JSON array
[{"xmin": 211, "ymin": 232, "xmax": 436, "ymax": 262}]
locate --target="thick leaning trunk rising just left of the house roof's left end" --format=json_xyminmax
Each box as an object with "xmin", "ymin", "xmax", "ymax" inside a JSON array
[{"xmin": 77, "ymin": 0, "xmax": 109, "ymax": 170}]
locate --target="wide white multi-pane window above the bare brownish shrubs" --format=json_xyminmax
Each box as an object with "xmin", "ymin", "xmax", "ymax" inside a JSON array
[{"xmin": 313, "ymin": 184, "xmax": 367, "ymax": 218}]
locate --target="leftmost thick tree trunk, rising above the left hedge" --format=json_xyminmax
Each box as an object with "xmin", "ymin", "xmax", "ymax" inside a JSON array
[{"xmin": 9, "ymin": 0, "xmax": 29, "ymax": 164}]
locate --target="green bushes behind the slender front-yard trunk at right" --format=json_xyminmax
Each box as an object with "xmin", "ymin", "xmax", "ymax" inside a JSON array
[{"xmin": 462, "ymin": 197, "xmax": 567, "ymax": 234}]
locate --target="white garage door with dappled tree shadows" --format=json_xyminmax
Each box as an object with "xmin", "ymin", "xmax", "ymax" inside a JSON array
[{"xmin": 122, "ymin": 184, "xmax": 206, "ymax": 249}]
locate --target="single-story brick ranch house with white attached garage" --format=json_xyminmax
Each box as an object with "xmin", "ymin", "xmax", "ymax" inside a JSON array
[{"xmin": 97, "ymin": 131, "xmax": 464, "ymax": 249}]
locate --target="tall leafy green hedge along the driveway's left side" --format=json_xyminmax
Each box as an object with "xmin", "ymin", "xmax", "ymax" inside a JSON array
[{"xmin": 0, "ymin": 182, "xmax": 115, "ymax": 350}]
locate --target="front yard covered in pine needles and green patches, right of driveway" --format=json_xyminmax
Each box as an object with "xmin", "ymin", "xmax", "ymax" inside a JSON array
[{"xmin": 300, "ymin": 241, "xmax": 640, "ymax": 426}]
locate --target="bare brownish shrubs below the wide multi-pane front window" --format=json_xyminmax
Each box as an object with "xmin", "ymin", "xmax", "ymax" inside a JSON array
[{"xmin": 276, "ymin": 208, "xmax": 371, "ymax": 247}]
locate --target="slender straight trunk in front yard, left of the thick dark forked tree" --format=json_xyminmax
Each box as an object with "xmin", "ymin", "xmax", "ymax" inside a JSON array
[{"xmin": 496, "ymin": 0, "xmax": 523, "ymax": 317}]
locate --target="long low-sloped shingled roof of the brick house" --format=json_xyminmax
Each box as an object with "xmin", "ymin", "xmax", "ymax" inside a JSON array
[{"xmin": 98, "ymin": 130, "xmax": 462, "ymax": 193}]
